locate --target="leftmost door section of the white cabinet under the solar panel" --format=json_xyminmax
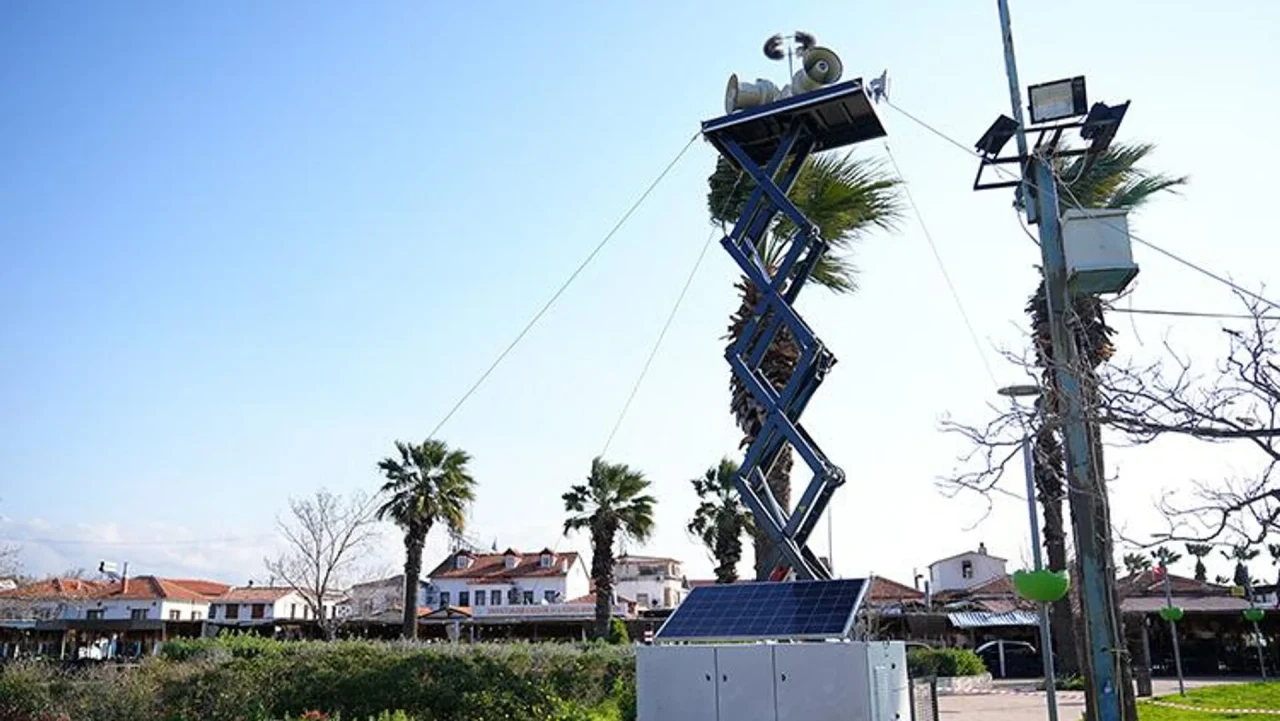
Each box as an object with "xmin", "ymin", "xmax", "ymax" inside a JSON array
[{"xmin": 636, "ymin": 645, "xmax": 717, "ymax": 721}]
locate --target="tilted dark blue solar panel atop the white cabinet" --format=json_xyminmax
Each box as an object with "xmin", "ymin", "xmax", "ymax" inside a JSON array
[{"xmin": 654, "ymin": 579, "xmax": 868, "ymax": 642}]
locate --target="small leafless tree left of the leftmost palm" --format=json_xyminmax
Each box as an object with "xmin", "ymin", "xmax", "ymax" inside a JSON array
[{"xmin": 264, "ymin": 488, "xmax": 375, "ymax": 639}]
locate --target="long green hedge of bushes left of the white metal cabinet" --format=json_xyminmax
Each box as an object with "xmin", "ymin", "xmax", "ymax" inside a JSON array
[{"xmin": 0, "ymin": 636, "xmax": 635, "ymax": 721}]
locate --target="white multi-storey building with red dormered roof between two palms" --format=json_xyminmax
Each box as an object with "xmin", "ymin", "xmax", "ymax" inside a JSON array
[{"xmin": 428, "ymin": 548, "xmax": 591, "ymax": 616}]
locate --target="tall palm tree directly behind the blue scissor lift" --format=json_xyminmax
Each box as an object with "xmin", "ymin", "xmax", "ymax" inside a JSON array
[{"xmin": 707, "ymin": 154, "xmax": 902, "ymax": 578}]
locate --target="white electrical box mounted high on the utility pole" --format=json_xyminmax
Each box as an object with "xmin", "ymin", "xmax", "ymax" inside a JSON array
[{"xmin": 1062, "ymin": 209, "xmax": 1138, "ymax": 295}]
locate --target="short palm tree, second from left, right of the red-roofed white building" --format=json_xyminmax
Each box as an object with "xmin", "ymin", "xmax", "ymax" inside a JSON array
[{"xmin": 562, "ymin": 458, "xmax": 657, "ymax": 638}]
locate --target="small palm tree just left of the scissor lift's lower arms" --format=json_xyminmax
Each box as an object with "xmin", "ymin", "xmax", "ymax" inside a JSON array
[{"xmin": 689, "ymin": 458, "xmax": 753, "ymax": 583}]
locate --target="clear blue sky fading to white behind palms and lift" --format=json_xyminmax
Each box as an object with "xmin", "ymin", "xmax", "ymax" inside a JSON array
[{"xmin": 0, "ymin": 0, "xmax": 1280, "ymax": 581}]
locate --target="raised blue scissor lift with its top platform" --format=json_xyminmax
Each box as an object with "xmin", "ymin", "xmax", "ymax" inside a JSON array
[{"xmin": 703, "ymin": 79, "xmax": 886, "ymax": 580}]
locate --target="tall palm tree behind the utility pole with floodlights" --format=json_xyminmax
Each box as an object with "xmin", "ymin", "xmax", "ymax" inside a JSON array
[{"xmin": 1027, "ymin": 143, "xmax": 1187, "ymax": 674}]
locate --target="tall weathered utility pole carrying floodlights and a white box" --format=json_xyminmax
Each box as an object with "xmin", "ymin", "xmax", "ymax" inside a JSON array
[{"xmin": 996, "ymin": 0, "xmax": 1124, "ymax": 721}]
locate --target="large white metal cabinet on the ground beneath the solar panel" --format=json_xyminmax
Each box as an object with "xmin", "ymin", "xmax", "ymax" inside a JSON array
[{"xmin": 636, "ymin": 642, "xmax": 911, "ymax": 721}]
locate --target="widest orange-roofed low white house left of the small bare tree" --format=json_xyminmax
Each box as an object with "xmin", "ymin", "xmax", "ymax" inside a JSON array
[{"xmin": 76, "ymin": 576, "xmax": 230, "ymax": 621}]
